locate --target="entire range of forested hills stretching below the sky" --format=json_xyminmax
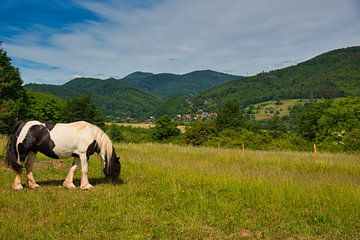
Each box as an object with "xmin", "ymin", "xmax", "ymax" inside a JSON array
[{"xmin": 25, "ymin": 47, "xmax": 360, "ymax": 119}]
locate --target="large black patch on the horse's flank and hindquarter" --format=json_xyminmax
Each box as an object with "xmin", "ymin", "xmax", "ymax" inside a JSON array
[{"xmin": 18, "ymin": 125, "xmax": 59, "ymax": 162}]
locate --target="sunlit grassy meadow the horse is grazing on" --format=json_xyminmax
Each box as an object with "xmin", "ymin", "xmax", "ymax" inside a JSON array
[{"xmin": 0, "ymin": 138, "xmax": 360, "ymax": 239}]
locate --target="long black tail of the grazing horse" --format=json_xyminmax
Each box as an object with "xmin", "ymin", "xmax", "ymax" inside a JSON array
[{"xmin": 5, "ymin": 122, "xmax": 24, "ymax": 173}]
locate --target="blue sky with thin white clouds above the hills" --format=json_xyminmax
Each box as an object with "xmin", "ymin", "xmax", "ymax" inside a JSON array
[{"xmin": 0, "ymin": 0, "xmax": 360, "ymax": 84}]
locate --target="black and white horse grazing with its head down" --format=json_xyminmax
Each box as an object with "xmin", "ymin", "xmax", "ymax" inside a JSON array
[{"xmin": 5, "ymin": 121, "xmax": 121, "ymax": 190}]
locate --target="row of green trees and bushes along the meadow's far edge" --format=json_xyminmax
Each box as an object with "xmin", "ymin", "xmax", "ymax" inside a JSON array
[{"xmin": 108, "ymin": 97, "xmax": 360, "ymax": 151}]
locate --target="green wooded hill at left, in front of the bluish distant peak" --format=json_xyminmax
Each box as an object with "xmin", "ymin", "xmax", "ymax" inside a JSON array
[{"xmin": 25, "ymin": 78, "xmax": 163, "ymax": 119}]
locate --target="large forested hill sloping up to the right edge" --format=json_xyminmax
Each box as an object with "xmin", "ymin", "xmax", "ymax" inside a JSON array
[{"xmin": 194, "ymin": 47, "xmax": 360, "ymax": 109}]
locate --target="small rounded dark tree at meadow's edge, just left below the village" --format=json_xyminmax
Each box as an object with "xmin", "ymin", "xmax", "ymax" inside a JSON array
[{"xmin": 152, "ymin": 115, "xmax": 180, "ymax": 141}]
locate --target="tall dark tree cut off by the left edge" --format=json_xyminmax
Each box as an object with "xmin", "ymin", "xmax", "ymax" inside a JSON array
[{"xmin": 0, "ymin": 43, "xmax": 27, "ymax": 134}]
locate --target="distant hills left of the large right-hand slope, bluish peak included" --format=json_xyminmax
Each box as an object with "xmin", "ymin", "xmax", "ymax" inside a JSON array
[{"xmin": 25, "ymin": 70, "xmax": 238, "ymax": 118}]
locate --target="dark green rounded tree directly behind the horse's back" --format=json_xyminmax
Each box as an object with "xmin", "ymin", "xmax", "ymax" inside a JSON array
[{"xmin": 63, "ymin": 94, "xmax": 104, "ymax": 127}]
